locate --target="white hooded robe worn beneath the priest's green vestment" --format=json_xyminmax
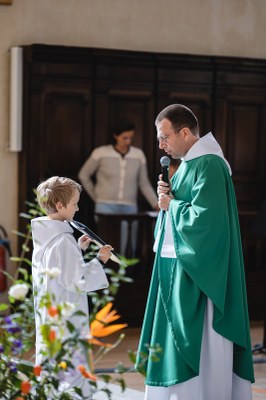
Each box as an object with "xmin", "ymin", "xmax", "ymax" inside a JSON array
[{"xmin": 149, "ymin": 133, "xmax": 252, "ymax": 400}]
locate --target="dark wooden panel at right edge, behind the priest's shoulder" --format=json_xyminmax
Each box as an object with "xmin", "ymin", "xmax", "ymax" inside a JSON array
[{"xmin": 216, "ymin": 92, "xmax": 266, "ymax": 210}]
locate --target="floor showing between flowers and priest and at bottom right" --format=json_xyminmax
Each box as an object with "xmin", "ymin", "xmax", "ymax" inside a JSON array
[{"xmin": 95, "ymin": 324, "xmax": 266, "ymax": 400}]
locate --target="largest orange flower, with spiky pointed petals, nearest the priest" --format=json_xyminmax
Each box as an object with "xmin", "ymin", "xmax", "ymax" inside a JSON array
[{"xmin": 90, "ymin": 302, "xmax": 127, "ymax": 342}]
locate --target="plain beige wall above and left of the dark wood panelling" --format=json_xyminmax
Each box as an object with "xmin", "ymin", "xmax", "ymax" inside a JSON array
[{"xmin": 0, "ymin": 0, "xmax": 266, "ymax": 294}]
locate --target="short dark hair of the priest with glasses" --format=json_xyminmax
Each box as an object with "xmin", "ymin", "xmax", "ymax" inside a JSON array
[{"xmin": 155, "ymin": 104, "xmax": 199, "ymax": 135}]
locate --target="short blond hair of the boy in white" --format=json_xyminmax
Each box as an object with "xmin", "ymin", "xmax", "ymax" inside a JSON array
[{"xmin": 36, "ymin": 176, "xmax": 82, "ymax": 214}]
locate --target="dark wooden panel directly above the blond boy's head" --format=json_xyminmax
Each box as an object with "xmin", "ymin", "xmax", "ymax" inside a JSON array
[{"xmin": 43, "ymin": 90, "xmax": 91, "ymax": 176}]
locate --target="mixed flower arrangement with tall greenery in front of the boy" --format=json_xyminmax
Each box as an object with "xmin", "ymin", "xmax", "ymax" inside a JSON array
[{"xmin": 0, "ymin": 195, "xmax": 138, "ymax": 400}]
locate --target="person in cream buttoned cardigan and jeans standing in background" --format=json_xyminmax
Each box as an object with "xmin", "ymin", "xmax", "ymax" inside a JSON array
[{"xmin": 78, "ymin": 120, "xmax": 158, "ymax": 254}]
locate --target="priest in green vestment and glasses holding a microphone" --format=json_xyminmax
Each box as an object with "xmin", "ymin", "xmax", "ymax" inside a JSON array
[{"xmin": 136, "ymin": 104, "xmax": 254, "ymax": 400}]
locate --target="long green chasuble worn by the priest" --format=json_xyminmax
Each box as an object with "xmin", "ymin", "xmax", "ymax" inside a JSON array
[{"xmin": 136, "ymin": 154, "xmax": 254, "ymax": 386}]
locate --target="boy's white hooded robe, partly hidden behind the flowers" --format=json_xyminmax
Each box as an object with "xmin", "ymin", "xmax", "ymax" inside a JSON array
[{"xmin": 31, "ymin": 217, "xmax": 109, "ymax": 395}]
